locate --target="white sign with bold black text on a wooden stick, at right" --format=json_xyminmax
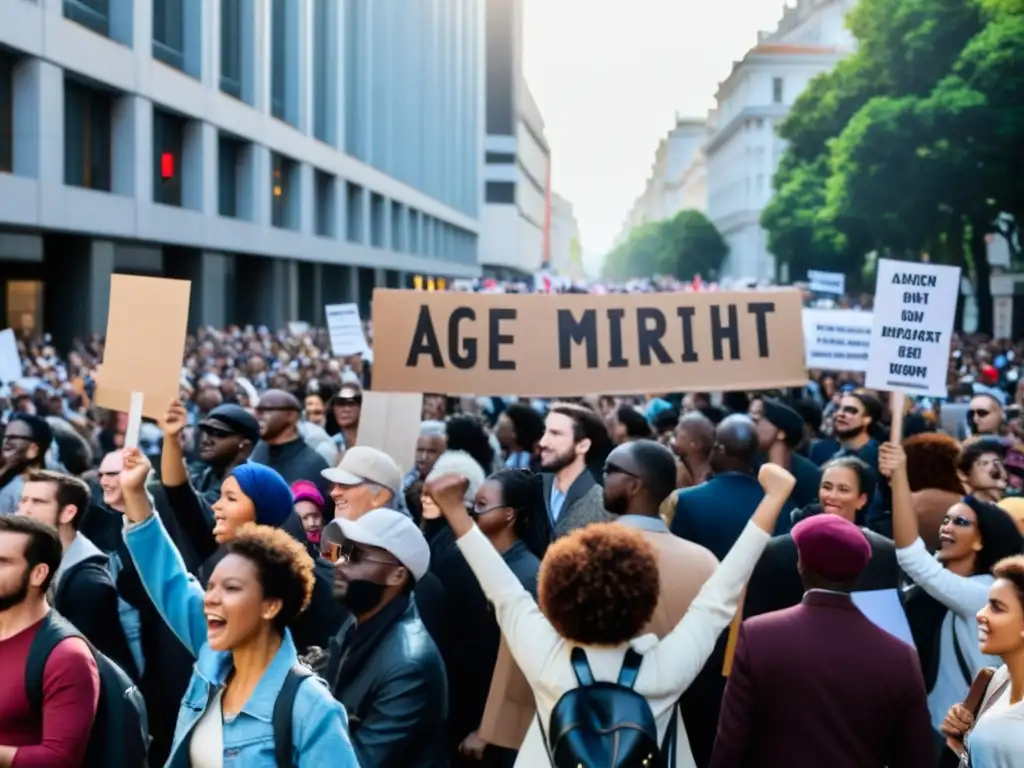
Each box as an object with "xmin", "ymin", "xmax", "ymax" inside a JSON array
[{"xmin": 865, "ymin": 259, "xmax": 959, "ymax": 397}]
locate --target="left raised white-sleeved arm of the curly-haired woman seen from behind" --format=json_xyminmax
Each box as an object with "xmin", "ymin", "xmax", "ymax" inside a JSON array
[{"xmin": 424, "ymin": 475, "xmax": 563, "ymax": 687}]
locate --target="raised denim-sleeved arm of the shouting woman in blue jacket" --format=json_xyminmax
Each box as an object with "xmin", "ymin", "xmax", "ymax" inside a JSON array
[{"xmin": 121, "ymin": 449, "xmax": 206, "ymax": 656}]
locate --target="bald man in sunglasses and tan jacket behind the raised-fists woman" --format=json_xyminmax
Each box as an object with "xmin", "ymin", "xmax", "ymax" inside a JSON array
[{"xmin": 604, "ymin": 440, "xmax": 721, "ymax": 765}]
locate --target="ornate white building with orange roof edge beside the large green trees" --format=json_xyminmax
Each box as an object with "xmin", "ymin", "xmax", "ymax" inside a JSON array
[{"xmin": 703, "ymin": 0, "xmax": 856, "ymax": 280}]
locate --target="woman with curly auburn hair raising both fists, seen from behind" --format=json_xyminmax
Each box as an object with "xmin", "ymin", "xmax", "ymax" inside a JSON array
[{"xmin": 427, "ymin": 464, "xmax": 795, "ymax": 768}]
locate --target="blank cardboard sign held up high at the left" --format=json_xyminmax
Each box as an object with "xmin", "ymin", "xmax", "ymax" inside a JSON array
[{"xmin": 96, "ymin": 274, "xmax": 191, "ymax": 419}]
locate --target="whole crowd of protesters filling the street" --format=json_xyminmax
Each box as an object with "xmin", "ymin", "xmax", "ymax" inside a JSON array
[{"xmin": 0, "ymin": 309, "xmax": 1024, "ymax": 768}]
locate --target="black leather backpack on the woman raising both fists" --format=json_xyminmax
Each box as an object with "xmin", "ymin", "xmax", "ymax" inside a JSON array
[{"xmin": 538, "ymin": 647, "xmax": 676, "ymax": 768}]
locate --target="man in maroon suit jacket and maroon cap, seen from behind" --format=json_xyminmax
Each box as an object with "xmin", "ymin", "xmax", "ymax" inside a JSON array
[{"xmin": 712, "ymin": 515, "xmax": 935, "ymax": 768}]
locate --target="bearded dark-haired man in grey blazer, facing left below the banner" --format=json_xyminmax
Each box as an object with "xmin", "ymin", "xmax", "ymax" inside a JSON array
[{"xmin": 540, "ymin": 402, "xmax": 611, "ymax": 539}]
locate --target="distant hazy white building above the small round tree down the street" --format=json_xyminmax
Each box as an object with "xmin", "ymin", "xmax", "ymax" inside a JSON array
[{"xmin": 616, "ymin": 116, "xmax": 707, "ymax": 244}]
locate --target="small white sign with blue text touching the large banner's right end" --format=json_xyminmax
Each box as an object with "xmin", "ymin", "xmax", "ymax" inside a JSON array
[{"xmin": 804, "ymin": 309, "xmax": 872, "ymax": 373}]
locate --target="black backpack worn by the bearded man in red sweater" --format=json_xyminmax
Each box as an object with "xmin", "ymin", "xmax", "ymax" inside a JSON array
[{"xmin": 25, "ymin": 610, "xmax": 150, "ymax": 768}]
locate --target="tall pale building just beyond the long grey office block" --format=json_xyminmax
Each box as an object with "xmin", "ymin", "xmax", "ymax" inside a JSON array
[{"xmin": 479, "ymin": 0, "xmax": 551, "ymax": 280}]
